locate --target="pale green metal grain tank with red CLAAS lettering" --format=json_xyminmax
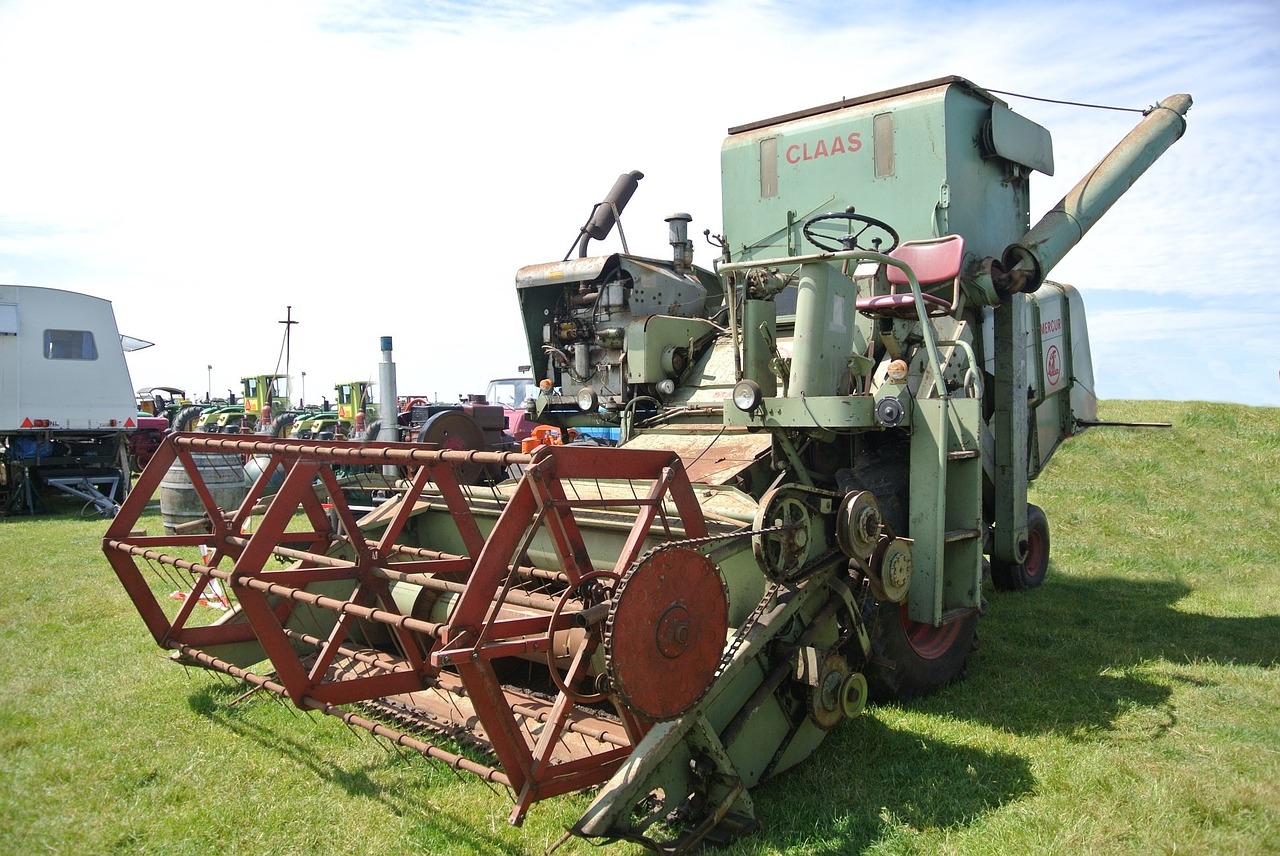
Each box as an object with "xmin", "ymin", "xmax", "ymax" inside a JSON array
[{"xmin": 721, "ymin": 78, "xmax": 1052, "ymax": 261}]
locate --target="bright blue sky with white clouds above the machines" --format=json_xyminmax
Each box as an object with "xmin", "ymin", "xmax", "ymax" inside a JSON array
[{"xmin": 0, "ymin": 0, "xmax": 1280, "ymax": 407}]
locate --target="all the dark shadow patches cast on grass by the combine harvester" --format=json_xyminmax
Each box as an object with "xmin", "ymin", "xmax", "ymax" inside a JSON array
[{"xmin": 172, "ymin": 562, "xmax": 1280, "ymax": 855}]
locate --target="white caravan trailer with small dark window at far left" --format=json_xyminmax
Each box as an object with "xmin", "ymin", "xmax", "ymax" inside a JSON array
[{"xmin": 0, "ymin": 285, "xmax": 150, "ymax": 514}]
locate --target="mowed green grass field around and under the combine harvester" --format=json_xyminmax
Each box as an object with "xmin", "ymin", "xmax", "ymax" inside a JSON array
[{"xmin": 0, "ymin": 402, "xmax": 1280, "ymax": 855}]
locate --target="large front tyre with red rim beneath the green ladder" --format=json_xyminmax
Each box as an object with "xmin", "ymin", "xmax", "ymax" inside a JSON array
[{"xmin": 867, "ymin": 601, "xmax": 978, "ymax": 701}]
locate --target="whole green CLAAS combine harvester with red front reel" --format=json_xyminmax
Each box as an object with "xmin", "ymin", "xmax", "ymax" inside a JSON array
[{"xmin": 104, "ymin": 78, "xmax": 1190, "ymax": 852}]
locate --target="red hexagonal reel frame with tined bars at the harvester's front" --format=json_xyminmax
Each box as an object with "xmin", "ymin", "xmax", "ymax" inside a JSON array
[{"xmin": 102, "ymin": 434, "xmax": 707, "ymax": 824}]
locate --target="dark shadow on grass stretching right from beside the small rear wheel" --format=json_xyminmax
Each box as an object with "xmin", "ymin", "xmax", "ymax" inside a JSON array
[{"xmin": 962, "ymin": 575, "xmax": 1280, "ymax": 738}]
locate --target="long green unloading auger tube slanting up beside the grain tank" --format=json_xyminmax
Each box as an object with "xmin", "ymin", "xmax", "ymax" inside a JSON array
[{"xmin": 993, "ymin": 95, "xmax": 1192, "ymax": 294}]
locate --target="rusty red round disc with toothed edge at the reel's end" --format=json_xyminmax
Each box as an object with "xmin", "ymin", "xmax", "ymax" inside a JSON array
[{"xmin": 604, "ymin": 546, "xmax": 728, "ymax": 722}]
